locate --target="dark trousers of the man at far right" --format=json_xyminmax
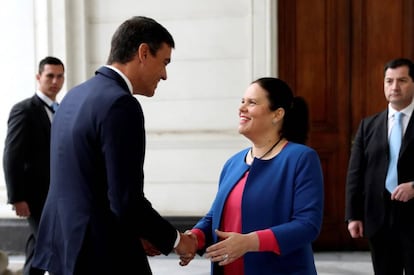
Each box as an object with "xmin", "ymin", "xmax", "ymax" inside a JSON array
[{"xmin": 369, "ymin": 202, "xmax": 414, "ymax": 275}]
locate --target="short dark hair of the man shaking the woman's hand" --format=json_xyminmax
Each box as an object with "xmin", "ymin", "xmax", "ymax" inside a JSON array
[{"xmin": 107, "ymin": 16, "xmax": 175, "ymax": 64}]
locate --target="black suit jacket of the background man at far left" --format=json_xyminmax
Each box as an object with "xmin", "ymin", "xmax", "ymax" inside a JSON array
[{"xmin": 3, "ymin": 95, "xmax": 50, "ymax": 222}]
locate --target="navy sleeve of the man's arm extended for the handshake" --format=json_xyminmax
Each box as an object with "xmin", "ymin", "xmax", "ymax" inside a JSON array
[{"xmin": 101, "ymin": 95, "xmax": 177, "ymax": 254}]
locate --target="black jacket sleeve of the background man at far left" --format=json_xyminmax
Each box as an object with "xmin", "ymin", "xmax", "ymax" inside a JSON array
[{"xmin": 3, "ymin": 105, "xmax": 29, "ymax": 204}]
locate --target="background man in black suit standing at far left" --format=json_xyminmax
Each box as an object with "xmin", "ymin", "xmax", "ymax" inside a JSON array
[{"xmin": 3, "ymin": 56, "xmax": 65, "ymax": 275}]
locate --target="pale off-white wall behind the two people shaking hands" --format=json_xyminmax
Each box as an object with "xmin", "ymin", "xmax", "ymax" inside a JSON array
[{"xmin": 0, "ymin": 0, "xmax": 276, "ymax": 216}]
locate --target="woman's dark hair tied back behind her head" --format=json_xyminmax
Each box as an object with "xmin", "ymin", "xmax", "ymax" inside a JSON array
[{"xmin": 252, "ymin": 77, "xmax": 309, "ymax": 144}]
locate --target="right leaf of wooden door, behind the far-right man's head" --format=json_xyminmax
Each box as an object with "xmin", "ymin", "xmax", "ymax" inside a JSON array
[{"xmin": 351, "ymin": 0, "xmax": 414, "ymax": 133}]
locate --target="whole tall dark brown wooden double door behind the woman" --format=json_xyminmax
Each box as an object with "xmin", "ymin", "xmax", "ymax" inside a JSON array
[{"xmin": 278, "ymin": 0, "xmax": 414, "ymax": 250}]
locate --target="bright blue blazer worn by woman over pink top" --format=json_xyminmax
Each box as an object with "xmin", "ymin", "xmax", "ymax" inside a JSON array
[{"xmin": 195, "ymin": 142, "xmax": 323, "ymax": 275}]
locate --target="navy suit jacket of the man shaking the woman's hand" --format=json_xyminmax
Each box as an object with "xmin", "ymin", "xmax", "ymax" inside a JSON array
[{"xmin": 34, "ymin": 67, "xmax": 177, "ymax": 275}]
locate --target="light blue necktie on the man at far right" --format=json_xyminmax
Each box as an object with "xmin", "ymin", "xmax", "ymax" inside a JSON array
[{"xmin": 385, "ymin": 112, "xmax": 403, "ymax": 193}]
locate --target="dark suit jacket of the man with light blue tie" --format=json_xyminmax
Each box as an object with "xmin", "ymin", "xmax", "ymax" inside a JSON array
[{"xmin": 345, "ymin": 111, "xmax": 414, "ymax": 237}]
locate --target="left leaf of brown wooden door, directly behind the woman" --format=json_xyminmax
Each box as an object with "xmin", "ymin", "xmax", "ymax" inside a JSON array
[{"xmin": 279, "ymin": 0, "xmax": 350, "ymax": 248}]
